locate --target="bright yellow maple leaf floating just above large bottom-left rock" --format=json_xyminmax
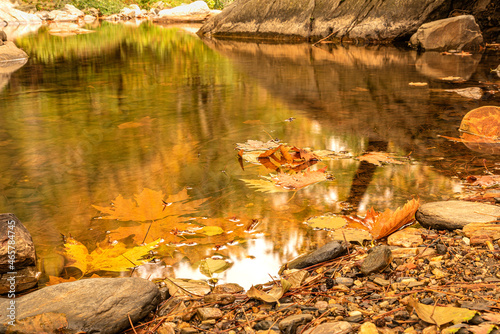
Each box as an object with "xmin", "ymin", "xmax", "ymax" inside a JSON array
[{"xmin": 64, "ymin": 237, "xmax": 161, "ymax": 275}]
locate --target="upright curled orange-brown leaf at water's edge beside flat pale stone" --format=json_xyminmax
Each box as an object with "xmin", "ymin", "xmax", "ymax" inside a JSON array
[{"xmin": 346, "ymin": 199, "xmax": 420, "ymax": 239}]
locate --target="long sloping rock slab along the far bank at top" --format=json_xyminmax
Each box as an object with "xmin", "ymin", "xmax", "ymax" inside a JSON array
[{"xmin": 198, "ymin": 0, "xmax": 499, "ymax": 42}]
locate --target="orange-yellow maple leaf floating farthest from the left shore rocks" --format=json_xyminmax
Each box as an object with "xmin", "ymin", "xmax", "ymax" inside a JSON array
[{"xmin": 92, "ymin": 188, "xmax": 202, "ymax": 222}]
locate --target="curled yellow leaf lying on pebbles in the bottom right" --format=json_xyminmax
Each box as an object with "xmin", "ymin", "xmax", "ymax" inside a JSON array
[{"xmin": 408, "ymin": 297, "xmax": 477, "ymax": 326}]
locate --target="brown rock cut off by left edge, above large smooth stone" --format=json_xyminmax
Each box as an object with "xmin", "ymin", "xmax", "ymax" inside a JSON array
[{"xmin": 0, "ymin": 213, "xmax": 39, "ymax": 294}]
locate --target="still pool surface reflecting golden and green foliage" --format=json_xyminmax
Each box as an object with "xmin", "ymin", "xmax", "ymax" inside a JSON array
[{"xmin": 0, "ymin": 23, "xmax": 500, "ymax": 288}]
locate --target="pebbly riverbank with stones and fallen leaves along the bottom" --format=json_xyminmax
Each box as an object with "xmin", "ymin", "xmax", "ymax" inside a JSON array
[{"xmin": 0, "ymin": 201, "xmax": 500, "ymax": 334}]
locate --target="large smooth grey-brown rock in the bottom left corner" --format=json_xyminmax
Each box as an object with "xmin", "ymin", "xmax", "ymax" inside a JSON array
[{"xmin": 0, "ymin": 277, "xmax": 160, "ymax": 334}]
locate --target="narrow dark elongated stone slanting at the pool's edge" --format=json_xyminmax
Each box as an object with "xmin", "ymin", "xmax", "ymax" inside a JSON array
[{"xmin": 279, "ymin": 241, "xmax": 347, "ymax": 274}]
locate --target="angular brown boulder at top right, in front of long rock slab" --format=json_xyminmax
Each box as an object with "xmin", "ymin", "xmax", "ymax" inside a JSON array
[{"xmin": 410, "ymin": 15, "xmax": 483, "ymax": 51}]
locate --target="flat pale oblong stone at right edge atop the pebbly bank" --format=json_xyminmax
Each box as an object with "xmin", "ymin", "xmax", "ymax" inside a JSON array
[{"xmin": 415, "ymin": 201, "xmax": 500, "ymax": 230}]
